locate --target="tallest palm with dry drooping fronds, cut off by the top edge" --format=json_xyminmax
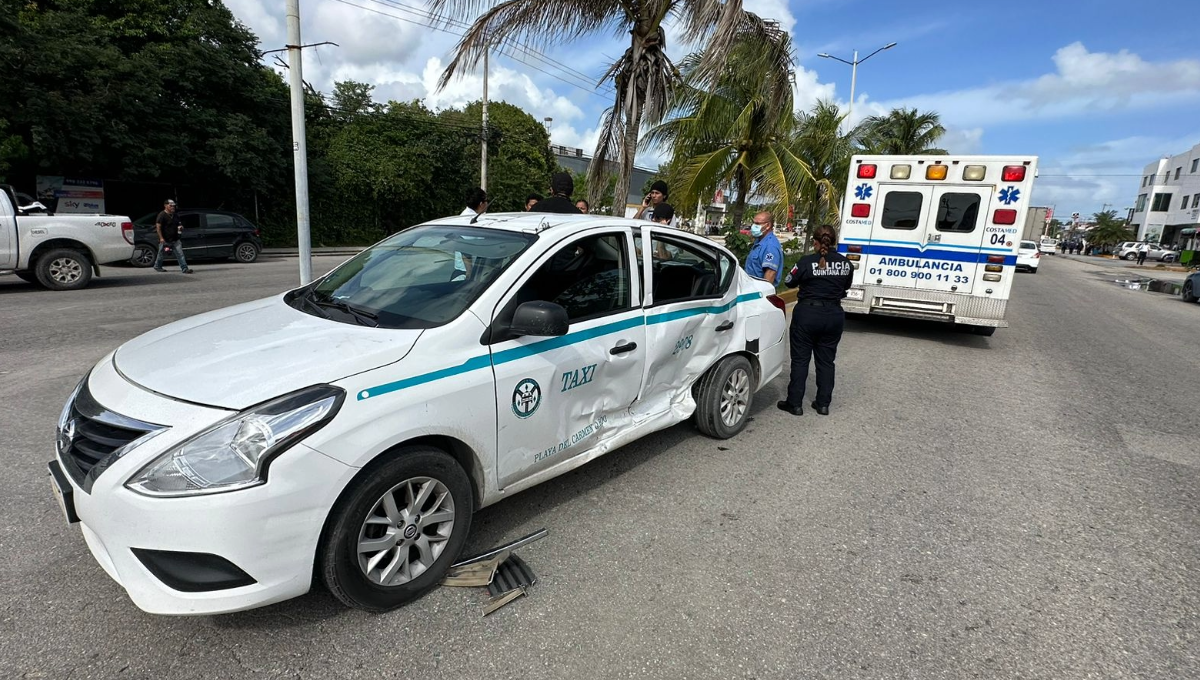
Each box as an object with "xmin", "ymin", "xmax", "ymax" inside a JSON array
[{"xmin": 431, "ymin": 0, "xmax": 779, "ymax": 207}]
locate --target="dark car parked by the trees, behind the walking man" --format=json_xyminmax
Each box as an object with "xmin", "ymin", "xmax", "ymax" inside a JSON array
[{"xmin": 130, "ymin": 210, "xmax": 263, "ymax": 266}]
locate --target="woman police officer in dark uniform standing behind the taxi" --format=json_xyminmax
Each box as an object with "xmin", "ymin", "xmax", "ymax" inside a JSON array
[{"xmin": 776, "ymin": 224, "xmax": 854, "ymax": 415}]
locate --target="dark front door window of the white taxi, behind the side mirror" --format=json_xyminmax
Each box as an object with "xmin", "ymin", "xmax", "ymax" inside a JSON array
[{"xmin": 508, "ymin": 233, "xmax": 632, "ymax": 323}]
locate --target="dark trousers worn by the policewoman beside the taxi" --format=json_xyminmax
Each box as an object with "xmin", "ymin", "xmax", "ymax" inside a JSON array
[{"xmin": 787, "ymin": 302, "xmax": 846, "ymax": 407}]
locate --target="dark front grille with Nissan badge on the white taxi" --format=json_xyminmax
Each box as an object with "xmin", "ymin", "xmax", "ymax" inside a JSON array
[{"xmin": 59, "ymin": 385, "xmax": 161, "ymax": 492}]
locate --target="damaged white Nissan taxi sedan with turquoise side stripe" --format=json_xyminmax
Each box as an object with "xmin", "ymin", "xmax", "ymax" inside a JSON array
[{"xmin": 50, "ymin": 213, "xmax": 787, "ymax": 614}]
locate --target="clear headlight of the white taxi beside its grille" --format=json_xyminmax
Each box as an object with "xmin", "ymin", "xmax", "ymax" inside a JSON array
[{"xmin": 125, "ymin": 385, "xmax": 346, "ymax": 497}]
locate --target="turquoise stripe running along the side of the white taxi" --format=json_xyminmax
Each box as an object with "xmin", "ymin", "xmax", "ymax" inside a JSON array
[{"xmin": 358, "ymin": 293, "xmax": 762, "ymax": 402}]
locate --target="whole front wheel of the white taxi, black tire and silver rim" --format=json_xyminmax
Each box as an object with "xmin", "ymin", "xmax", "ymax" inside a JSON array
[{"xmin": 317, "ymin": 446, "xmax": 475, "ymax": 612}]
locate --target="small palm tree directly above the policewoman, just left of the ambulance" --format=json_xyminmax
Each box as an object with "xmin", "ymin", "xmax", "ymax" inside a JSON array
[{"xmin": 790, "ymin": 100, "xmax": 863, "ymax": 235}]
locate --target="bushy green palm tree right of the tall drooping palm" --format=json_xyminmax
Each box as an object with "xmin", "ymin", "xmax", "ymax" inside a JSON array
[{"xmin": 643, "ymin": 32, "xmax": 810, "ymax": 225}]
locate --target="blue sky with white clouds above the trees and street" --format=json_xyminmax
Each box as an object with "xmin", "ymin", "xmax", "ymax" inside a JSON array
[{"xmin": 226, "ymin": 0, "xmax": 1200, "ymax": 215}]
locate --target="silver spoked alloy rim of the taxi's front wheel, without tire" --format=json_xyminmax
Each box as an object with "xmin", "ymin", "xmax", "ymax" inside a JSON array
[{"xmin": 358, "ymin": 477, "xmax": 455, "ymax": 586}]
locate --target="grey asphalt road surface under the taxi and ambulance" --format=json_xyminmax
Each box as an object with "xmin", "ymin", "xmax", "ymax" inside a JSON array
[{"xmin": 0, "ymin": 257, "xmax": 1200, "ymax": 680}]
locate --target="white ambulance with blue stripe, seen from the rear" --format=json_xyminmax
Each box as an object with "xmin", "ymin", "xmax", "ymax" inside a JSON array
[{"xmin": 838, "ymin": 156, "xmax": 1038, "ymax": 336}]
